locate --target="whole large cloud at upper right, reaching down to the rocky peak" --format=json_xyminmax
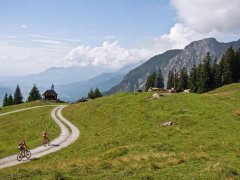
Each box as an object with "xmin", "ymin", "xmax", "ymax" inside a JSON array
[{"xmin": 149, "ymin": 0, "xmax": 240, "ymax": 52}]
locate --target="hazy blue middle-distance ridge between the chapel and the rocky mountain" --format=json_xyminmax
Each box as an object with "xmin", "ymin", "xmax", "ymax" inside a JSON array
[{"xmin": 55, "ymin": 63, "xmax": 139, "ymax": 101}]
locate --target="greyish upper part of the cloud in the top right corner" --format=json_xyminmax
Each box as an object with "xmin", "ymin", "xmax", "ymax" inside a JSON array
[{"xmin": 171, "ymin": 0, "xmax": 240, "ymax": 33}]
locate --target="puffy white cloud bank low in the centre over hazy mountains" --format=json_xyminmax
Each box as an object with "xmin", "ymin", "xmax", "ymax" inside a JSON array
[{"xmin": 65, "ymin": 41, "xmax": 152, "ymax": 68}]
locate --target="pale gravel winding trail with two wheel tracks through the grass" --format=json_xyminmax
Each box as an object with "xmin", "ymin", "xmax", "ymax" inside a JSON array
[{"xmin": 0, "ymin": 105, "xmax": 80, "ymax": 169}]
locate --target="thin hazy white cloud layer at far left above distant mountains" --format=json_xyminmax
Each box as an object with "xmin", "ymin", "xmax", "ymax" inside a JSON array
[{"xmin": 0, "ymin": 41, "xmax": 71, "ymax": 75}]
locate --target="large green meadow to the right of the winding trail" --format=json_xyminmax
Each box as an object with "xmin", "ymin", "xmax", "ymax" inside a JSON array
[{"xmin": 0, "ymin": 84, "xmax": 240, "ymax": 179}]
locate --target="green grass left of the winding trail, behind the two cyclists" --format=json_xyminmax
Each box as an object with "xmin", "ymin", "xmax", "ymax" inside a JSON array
[{"xmin": 0, "ymin": 102, "xmax": 60, "ymax": 158}]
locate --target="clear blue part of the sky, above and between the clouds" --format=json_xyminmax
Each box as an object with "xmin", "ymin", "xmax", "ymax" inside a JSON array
[{"xmin": 0, "ymin": 0, "xmax": 175, "ymax": 46}]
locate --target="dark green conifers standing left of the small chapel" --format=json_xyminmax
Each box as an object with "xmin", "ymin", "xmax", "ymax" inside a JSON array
[{"xmin": 3, "ymin": 84, "xmax": 42, "ymax": 106}]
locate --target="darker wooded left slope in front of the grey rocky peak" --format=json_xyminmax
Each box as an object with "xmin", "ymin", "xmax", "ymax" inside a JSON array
[{"xmin": 106, "ymin": 50, "xmax": 182, "ymax": 94}]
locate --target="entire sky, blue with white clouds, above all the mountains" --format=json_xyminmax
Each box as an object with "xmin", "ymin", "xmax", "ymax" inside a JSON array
[{"xmin": 0, "ymin": 0, "xmax": 240, "ymax": 75}]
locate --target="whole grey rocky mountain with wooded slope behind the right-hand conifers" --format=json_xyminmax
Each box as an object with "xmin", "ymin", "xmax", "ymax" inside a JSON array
[{"xmin": 107, "ymin": 38, "xmax": 240, "ymax": 94}]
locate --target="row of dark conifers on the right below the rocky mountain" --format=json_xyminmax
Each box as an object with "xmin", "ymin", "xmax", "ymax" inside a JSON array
[{"xmin": 145, "ymin": 47, "xmax": 240, "ymax": 93}]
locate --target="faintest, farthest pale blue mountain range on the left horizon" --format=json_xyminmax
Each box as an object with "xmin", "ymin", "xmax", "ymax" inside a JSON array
[{"xmin": 0, "ymin": 66, "xmax": 115, "ymax": 88}]
